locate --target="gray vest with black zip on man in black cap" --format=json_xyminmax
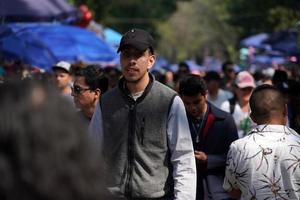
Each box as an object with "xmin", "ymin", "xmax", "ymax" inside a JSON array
[{"xmin": 101, "ymin": 77, "xmax": 176, "ymax": 199}]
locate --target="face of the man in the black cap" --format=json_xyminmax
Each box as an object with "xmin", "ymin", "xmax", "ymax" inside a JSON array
[{"xmin": 120, "ymin": 47, "xmax": 155, "ymax": 83}]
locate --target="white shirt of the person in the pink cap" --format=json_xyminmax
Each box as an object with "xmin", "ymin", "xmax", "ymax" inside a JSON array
[{"xmin": 221, "ymin": 101, "xmax": 255, "ymax": 138}]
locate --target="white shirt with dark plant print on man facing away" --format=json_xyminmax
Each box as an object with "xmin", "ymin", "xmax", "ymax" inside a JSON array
[{"xmin": 223, "ymin": 125, "xmax": 300, "ymax": 200}]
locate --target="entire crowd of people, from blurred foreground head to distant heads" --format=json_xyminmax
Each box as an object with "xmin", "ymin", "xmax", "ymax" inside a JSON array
[{"xmin": 0, "ymin": 29, "xmax": 300, "ymax": 200}]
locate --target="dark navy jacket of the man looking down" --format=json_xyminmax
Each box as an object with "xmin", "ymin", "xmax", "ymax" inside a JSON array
[{"xmin": 188, "ymin": 102, "xmax": 238, "ymax": 200}]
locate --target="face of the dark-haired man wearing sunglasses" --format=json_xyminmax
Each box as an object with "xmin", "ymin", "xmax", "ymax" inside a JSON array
[{"xmin": 72, "ymin": 76, "xmax": 99, "ymax": 110}]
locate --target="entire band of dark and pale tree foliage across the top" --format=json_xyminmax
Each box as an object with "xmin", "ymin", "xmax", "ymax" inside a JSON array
[{"xmin": 69, "ymin": 0, "xmax": 300, "ymax": 61}]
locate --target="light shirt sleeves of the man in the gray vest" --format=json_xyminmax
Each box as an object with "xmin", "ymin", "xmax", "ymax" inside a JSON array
[{"xmin": 89, "ymin": 96, "xmax": 196, "ymax": 200}]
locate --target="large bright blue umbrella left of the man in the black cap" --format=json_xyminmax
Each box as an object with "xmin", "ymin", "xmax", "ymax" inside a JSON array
[{"xmin": 0, "ymin": 24, "xmax": 118, "ymax": 70}]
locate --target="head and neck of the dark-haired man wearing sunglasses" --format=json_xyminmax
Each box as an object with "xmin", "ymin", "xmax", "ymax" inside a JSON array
[{"xmin": 72, "ymin": 65, "xmax": 108, "ymax": 122}]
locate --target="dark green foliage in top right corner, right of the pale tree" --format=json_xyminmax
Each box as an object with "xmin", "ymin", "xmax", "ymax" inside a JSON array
[{"xmin": 227, "ymin": 0, "xmax": 300, "ymax": 37}]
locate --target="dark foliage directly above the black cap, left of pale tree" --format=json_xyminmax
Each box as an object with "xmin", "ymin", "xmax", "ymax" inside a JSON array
[{"xmin": 72, "ymin": 0, "xmax": 176, "ymax": 34}]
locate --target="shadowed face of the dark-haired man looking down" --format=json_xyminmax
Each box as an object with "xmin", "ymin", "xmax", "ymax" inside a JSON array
[{"xmin": 181, "ymin": 94, "xmax": 206, "ymax": 119}]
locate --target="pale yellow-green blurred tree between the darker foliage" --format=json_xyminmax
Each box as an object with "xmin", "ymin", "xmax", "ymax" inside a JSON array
[{"xmin": 158, "ymin": 0, "xmax": 236, "ymax": 60}]
